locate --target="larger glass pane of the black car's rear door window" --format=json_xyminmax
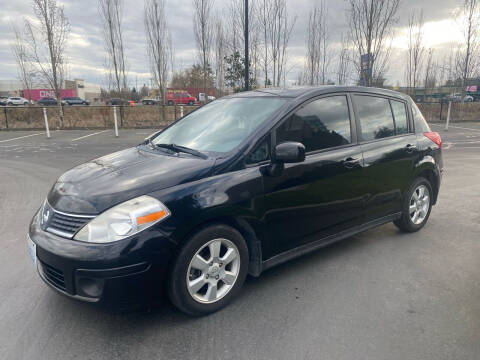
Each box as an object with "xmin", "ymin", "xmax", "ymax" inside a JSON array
[{"xmin": 354, "ymin": 95, "xmax": 395, "ymax": 141}]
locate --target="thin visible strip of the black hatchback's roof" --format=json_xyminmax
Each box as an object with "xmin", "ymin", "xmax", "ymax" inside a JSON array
[{"xmin": 231, "ymin": 85, "xmax": 408, "ymax": 99}]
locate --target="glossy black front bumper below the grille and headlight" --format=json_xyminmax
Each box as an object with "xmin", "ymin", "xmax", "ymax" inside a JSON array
[{"xmin": 29, "ymin": 211, "xmax": 173, "ymax": 307}]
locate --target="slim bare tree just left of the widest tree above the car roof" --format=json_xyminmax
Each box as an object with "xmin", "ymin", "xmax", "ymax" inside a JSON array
[{"xmin": 305, "ymin": 0, "xmax": 331, "ymax": 85}]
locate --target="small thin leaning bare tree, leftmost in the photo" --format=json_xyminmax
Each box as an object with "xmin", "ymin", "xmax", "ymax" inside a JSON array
[{"xmin": 12, "ymin": 24, "xmax": 35, "ymax": 100}]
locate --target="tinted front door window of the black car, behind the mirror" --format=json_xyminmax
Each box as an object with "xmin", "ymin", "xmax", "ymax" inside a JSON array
[{"xmin": 277, "ymin": 96, "xmax": 351, "ymax": 152}]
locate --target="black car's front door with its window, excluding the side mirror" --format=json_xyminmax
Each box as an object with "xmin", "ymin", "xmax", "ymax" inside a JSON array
[{"xmin": 264, "ymin": 94, "xmax": 365, "ymax": 252}]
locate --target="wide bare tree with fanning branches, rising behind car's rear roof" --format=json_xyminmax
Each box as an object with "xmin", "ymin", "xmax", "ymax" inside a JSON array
[{"xmin": 348, "ymin": 0, "xmax": 400, "ymax": 86}]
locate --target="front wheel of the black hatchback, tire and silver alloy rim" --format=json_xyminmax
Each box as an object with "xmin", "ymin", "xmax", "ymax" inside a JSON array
[{"xmin": 168, "ymin": 224, "xmax": 248, "ymax": 316}]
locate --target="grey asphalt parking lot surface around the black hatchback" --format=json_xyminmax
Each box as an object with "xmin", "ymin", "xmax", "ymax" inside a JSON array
[{"xmin": 0, "ymin": 123, "xmax": 480, "ymax": 360}]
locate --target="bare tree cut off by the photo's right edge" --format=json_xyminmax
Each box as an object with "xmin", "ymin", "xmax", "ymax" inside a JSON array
[{"xmin": 457, "ymin": 0, "xmax": 480, "ymax": 91}]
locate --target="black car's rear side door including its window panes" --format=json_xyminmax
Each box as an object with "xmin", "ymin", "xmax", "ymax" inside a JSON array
[{"xmin": 352, "ymin": 94, "xmax": 418, "ymax": 222}]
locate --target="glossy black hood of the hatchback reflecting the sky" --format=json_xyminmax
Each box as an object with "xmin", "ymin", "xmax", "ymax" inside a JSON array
[{"xmin": 47, "ymin": 147, "xmax": 215, "ymax": 214}]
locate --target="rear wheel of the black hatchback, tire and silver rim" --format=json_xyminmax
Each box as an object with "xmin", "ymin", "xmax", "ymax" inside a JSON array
[{"xmin": 393, "ymin": 177, "xmax": 433, "ymax": 232}]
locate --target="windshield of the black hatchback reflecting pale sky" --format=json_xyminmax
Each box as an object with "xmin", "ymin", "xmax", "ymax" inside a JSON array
[{"xmin": 153, "ymin": 97, "xmax": 286, "ymax": 152}]
